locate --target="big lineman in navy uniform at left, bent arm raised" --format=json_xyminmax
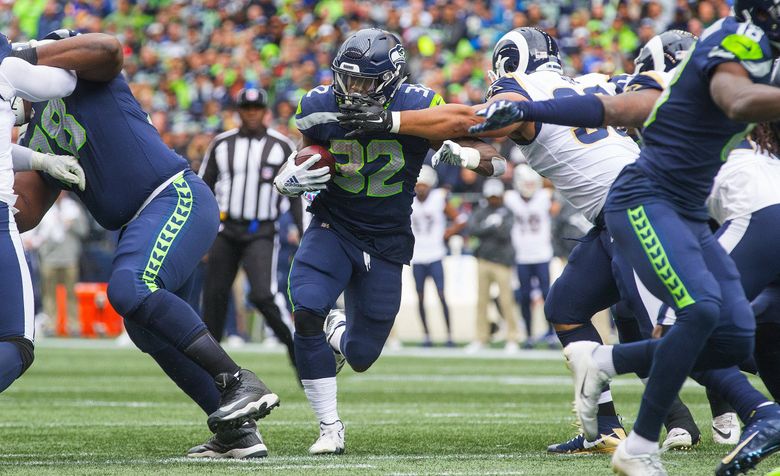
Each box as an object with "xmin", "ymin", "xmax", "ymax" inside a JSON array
[{"xmin": 11, "ymin": 30, "xmax": 279, "ymax": 457}]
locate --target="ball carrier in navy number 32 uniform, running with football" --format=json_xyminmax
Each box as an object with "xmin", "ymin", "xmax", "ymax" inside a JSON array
[{"xmin": 275, "ymin": 28, "xmax": 505, "ymax": 454}]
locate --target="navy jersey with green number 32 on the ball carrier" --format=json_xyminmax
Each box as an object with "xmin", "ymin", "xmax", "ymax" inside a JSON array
[{"xmin": 295, "ymin": 84, "xmax": 443, "ymax": 263}]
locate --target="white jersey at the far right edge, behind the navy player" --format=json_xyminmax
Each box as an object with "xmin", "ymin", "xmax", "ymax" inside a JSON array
[{"xmin": 707, "ymin": 149, "xmax": 780, "ymax": 223}]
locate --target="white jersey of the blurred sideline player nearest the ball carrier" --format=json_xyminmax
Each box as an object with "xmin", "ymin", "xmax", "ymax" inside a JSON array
[{"xmin": 412, "ymin": 188, "xmax": 447, "ymax": 264}]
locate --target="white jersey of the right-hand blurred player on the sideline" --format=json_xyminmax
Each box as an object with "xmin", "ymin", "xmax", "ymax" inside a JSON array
[{"xmin": 504, "ymin": 188, "xmax": 553, "ymax": 264}]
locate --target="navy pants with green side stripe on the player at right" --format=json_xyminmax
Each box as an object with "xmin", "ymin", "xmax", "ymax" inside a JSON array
[{"xmin": 606, "ymin": 203, "xmax": 755, "ymax": 441}]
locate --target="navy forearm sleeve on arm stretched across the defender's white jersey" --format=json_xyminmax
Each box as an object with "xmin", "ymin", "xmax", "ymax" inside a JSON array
[{"xmin": 524, "ymin": 94, "xmax": 604, "ymax": 128}]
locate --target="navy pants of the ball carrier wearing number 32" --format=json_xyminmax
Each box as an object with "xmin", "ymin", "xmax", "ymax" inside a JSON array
[{"xmin": 289, "ymin": 219, "xmax": 402, "ymax": 380}]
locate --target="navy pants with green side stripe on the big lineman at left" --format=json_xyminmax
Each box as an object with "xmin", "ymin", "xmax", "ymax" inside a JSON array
[{"xmin": 108, "ymin": 170, "xmax": 219, "ymax": 413}]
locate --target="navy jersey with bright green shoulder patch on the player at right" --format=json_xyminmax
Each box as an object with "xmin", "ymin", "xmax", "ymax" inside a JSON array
[{"xmin": 606, "ymin": 17, "xmax": 772, "ymax": 220}]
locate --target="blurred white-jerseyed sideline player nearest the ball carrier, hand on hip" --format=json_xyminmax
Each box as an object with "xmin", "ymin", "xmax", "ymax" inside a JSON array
[{"xmin": 412, "ymin": 165, "xmax": 466, "ymax": 347}]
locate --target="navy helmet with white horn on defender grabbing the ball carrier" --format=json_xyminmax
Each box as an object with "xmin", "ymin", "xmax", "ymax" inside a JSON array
[{"xmin": 488, "ymin": 27, "xmax": 563, "ymax": 81}]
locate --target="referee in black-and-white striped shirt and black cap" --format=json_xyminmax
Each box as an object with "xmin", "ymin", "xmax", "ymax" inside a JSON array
[{"xmin": 199, "ymin": 88, "xmax": 303, "ymax": 365}]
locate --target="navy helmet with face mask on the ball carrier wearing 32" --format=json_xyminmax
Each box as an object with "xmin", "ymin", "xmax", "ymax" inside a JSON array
[{"xmin": 331, "ymin": 28, "xmax": 406, "ymax": 109}]
